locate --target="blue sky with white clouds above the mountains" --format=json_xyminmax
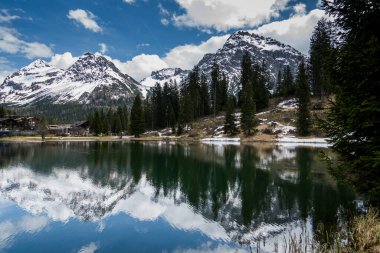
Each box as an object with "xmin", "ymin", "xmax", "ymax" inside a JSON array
[{"xmin": 0, "ymin": 0, "xmax": 324, "ymax": 80}]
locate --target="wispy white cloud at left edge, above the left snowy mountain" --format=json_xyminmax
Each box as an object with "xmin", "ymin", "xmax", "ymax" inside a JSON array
[{"xmin": 0, "ymin": 26, "xmax": 53, "ymax": 59}]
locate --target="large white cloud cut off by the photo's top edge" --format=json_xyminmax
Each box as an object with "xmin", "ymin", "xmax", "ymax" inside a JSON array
[{"xmin": 173, "ymin": 0, "xmax": 289, "ymax": 31}]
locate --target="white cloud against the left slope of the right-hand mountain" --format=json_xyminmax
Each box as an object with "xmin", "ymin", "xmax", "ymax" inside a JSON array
[{"xmin": 163, "ymin": 35, "xmax": 230, "ymax": 69}]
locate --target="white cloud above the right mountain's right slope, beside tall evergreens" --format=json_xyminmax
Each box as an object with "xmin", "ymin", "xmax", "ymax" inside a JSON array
[{"xmin": 252, "ymin": 9, "xmax": 327, "ymax": 54}]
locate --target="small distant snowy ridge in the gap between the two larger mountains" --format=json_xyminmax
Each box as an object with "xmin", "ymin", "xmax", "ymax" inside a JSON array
[{"xmin": 141, "ymin": 68, "xmax": 190, "ymax": 89}]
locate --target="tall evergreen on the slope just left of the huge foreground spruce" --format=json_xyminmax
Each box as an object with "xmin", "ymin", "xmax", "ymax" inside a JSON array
[{"xmin": 309, "ymin": 18, "xmax": 334, "ymax": 98}]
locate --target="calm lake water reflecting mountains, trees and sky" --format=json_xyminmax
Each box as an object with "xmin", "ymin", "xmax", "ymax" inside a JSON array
[{"xmin": 0, "ymin": 143, "xmax": 358, "ymax": 253}]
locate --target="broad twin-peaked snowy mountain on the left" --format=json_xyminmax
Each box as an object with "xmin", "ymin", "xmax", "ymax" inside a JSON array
[{"xmin": 0, "ymin": 53, "xmax": 143, "ymax": 106}]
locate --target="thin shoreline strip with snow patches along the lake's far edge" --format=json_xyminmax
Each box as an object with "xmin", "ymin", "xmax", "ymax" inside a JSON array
[{"xmin": 0, "ymin": 136, "xmax": 330, "ymax": 147}]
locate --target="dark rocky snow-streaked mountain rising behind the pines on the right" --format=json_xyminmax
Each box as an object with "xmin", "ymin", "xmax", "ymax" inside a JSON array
[{"xmin": 197, "ymin": 31, "xmax": 302, "ymax": 92}]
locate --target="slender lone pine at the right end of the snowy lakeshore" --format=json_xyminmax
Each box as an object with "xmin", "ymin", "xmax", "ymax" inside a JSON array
[{"xmin": 296, "ymin": 60, "xmax": 311, "ymax": 136}]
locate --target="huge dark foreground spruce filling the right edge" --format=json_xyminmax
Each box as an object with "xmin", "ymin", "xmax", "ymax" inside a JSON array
[{"xmin": 320, "ymin": 0, "xmax": 380, "ymax": 203}]
